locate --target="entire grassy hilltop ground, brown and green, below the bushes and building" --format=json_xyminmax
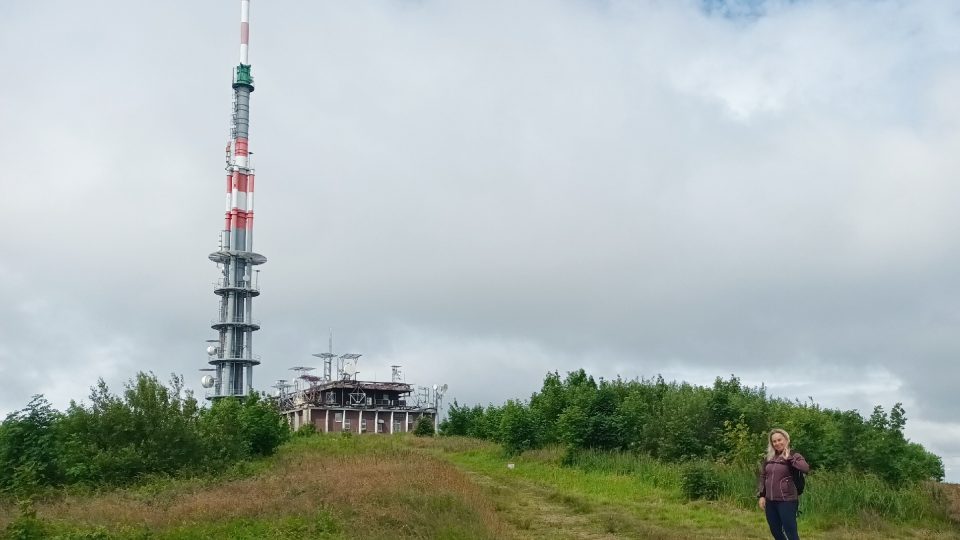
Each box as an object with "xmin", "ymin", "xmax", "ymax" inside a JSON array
[{"xmin": 0, "ymin": 435, "xmax": 960, "ymax": 540}]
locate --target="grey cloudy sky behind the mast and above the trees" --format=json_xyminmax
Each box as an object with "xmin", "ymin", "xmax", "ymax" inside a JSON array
[{"xmin": 0, "ymin": 0, "xmax": 960, "ymax": 481}]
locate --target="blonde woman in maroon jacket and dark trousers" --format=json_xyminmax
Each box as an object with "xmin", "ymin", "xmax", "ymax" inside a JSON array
[{"xmin": 757, "ymin": 428, "xmax": 810, "ymax": 540}]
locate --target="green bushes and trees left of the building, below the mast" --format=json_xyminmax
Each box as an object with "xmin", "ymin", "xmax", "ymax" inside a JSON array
[{"xmin": 0, "ymin": 373, "xmax": 289, "ymax": 494}]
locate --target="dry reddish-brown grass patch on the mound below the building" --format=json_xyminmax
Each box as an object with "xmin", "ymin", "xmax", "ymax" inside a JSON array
[{"xmin": 0, "ymin": 437, "xmax": 503, "ymax": 538}]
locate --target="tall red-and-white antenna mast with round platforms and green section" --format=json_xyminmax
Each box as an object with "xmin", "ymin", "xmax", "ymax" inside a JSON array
[{"xmin": 207, "ymin": 0, "xmax": 267, "ymax": 399}]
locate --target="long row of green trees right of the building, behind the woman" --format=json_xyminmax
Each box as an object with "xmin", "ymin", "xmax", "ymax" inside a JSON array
[{"xmin": 441, "ymin": 369, "xmax": 944, "ymax": 486}]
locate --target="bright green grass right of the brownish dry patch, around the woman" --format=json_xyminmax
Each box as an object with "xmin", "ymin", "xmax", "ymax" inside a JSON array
[{"xmin": 434, "ymin": 445, "xmax": 960, "ymax": 538}]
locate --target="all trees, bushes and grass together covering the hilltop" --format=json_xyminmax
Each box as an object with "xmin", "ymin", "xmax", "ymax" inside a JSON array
[{"xmin": 0, "ymin": 371, "xmax": 960, "ymax": 540}]
